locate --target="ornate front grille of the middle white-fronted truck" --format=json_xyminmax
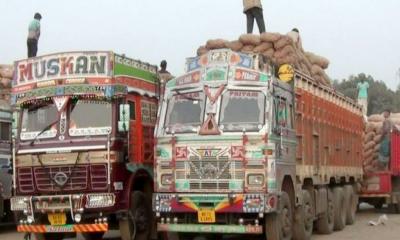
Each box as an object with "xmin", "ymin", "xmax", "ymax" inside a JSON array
[{"xmin": 175, "ymin": 156, "xmax": 244, "ymax": 191}]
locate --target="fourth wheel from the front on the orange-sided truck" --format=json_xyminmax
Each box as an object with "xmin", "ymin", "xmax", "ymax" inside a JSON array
[{"xmin": 333, "ymin": 187, "xmax": 346, "ymax": 231}]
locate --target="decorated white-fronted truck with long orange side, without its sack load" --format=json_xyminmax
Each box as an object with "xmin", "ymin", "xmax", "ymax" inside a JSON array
[{"xmin": 153, "ymin": 49, "xmax": 364, "ymax": 240}]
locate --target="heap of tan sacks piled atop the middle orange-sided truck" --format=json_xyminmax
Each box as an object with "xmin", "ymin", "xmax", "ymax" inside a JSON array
[{"xmin": 197, "ymin": 33, "xmax": 331, "ymax": 85}]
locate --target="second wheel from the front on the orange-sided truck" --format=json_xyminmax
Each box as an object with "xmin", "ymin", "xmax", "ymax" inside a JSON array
[{"xmin": 293, "ymin": 190, "xmax": 314, "ymax": 240}]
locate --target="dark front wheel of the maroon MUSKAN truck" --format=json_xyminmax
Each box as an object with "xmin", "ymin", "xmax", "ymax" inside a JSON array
[{"xmin": 119, "ymin": 191, "xmax": 152, "ymax": 240}]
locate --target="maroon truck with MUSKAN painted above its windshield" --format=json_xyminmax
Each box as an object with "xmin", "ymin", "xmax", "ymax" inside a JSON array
[{"xmin": 11, "ymin": 51, "xmax": 158, "ymax": 240}]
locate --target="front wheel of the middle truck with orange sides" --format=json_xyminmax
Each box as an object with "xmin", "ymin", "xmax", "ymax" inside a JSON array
[{"xmin": 265, "ymin": 192, "xmax": 293, "ymax": 240}]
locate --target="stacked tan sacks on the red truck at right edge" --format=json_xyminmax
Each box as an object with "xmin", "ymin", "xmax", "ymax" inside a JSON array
[{"xmin": 363, "ymin": 113, "xmax": 400, "ymax": 173}]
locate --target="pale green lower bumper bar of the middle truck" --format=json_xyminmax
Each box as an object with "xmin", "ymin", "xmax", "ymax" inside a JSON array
[{"xmin": 157, "ymin": 223, "xmax": 263, "ymax": 234}]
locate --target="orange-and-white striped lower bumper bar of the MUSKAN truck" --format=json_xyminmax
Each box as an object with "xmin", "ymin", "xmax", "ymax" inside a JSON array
[{"xmin": 17, "ymin": 223, "xmax": 108, "ymax": 233}]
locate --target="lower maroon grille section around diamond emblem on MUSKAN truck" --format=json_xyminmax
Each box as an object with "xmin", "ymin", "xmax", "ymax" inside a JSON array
[{"xmin": 34, "ymin": 166, "xmax": 89, "ymax": 192}]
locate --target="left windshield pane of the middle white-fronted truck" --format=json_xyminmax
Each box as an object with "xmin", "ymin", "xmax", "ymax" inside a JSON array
[{"xmin": 165, "ymin": 92, "xmax": 204, "ymax": 133}]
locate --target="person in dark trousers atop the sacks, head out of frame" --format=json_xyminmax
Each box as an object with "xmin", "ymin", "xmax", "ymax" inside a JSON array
[{"xmin": 243, "ymin": 0, "xmax": 265, "ymax": 33}]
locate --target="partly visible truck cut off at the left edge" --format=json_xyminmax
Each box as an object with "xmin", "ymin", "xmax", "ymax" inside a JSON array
[{"xmin": 0, "ymin": 99, "xmax": 12, "ymax": 222}]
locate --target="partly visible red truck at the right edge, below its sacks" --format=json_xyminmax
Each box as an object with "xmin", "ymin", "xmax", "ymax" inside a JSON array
[{"xmin": 360, "ymin": 131, "xmax": 400, "ymax": 213}]
